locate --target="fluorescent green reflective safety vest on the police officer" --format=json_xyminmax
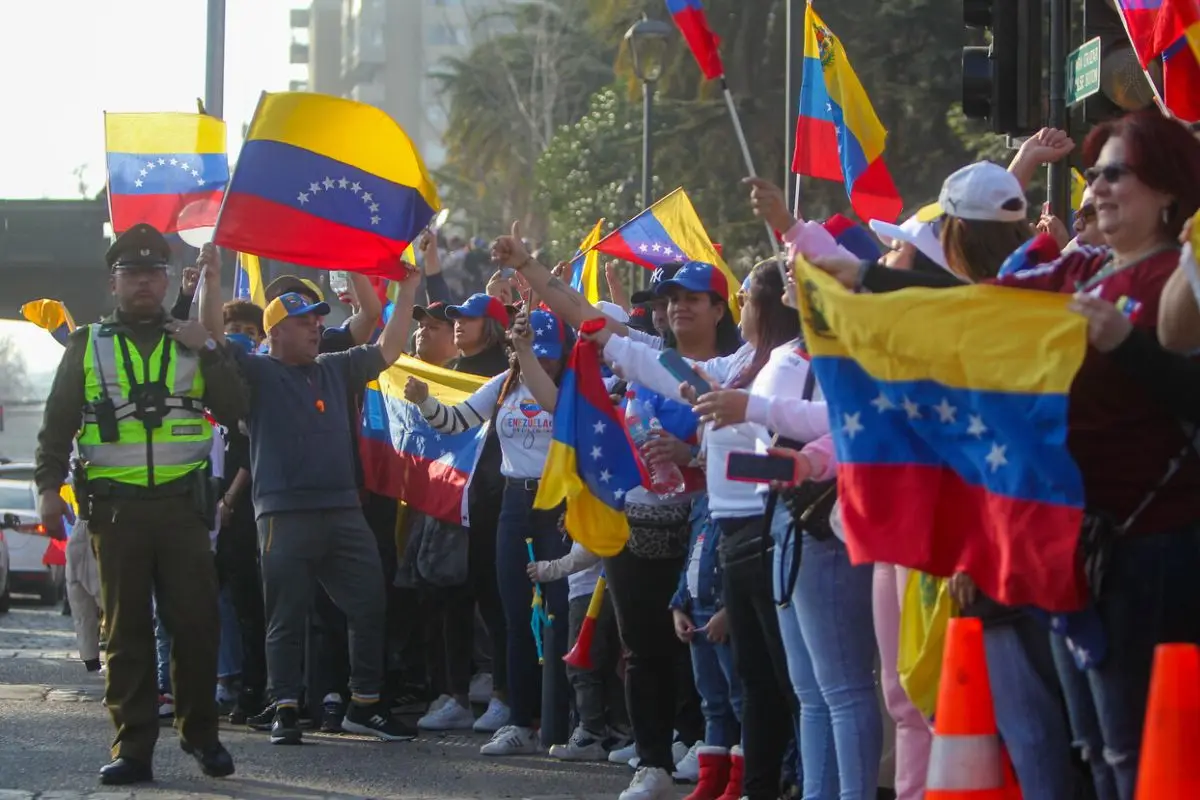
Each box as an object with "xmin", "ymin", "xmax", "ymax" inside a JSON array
[{"xmin": 77, "ymin": 324, "xmax": 212, "ymax": 487}]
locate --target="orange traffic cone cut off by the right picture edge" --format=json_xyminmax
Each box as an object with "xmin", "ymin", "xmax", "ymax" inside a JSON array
[{"xmin": 1136, "ymin": 644, "xmax": 1200, "ymax": 800}]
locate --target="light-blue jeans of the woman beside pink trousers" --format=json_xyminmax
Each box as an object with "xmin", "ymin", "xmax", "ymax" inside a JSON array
[{"xmin": 772, "ymin": 509, "xmax": 883, "ymax": 800}]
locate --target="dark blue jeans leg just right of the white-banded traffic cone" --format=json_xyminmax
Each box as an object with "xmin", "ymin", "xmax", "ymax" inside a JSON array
[{"xmin": 983, "ymin": 616, "xmax": 1075, "ymax": 800}]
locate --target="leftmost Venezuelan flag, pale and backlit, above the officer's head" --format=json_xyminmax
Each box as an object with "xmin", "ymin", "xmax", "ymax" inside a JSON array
[{"xmin": 104, "ymin": 113, "xmax": 229, "ymax": 234}]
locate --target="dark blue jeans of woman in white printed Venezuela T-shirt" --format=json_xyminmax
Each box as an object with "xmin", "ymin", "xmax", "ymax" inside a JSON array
[{"xmin": 496, "ymin": 486, "xmax": 571, "ymax": 728}]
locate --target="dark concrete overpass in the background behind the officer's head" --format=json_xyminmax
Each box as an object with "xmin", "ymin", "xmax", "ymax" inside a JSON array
[{"xmin": 0, "ymin": 199, "xmax": 341, "ymax": 325}]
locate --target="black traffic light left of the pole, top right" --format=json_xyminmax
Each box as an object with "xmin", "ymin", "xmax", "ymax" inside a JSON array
[{"xmin": 962, "ymin": 0, "xmax": 1041, "ymax": 136}]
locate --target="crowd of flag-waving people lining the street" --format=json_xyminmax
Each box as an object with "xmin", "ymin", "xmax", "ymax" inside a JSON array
[{"xmin": 37, "ymin": 106, "xmax": 1200, "ymax": 800}]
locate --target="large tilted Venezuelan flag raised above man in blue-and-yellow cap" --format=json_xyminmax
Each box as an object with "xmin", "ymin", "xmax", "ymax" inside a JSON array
[{"xmin": 215, "ymin": 92, "xmax": 442, "ymax": 278}]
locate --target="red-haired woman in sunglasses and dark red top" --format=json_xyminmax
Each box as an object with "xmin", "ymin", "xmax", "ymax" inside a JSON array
[{"xmin": 817, "ymin": 110, "xmax": 1200, "ymax": 800}]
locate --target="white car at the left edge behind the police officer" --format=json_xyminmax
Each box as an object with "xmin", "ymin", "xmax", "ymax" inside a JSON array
[{"xmin": 0, "ymin": 476, "xmax": 66, "ymax": 604}]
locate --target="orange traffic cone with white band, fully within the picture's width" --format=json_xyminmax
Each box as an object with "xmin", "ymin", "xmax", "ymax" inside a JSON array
[{"xmin": 925, "ymin": 618, "xmax": 1021, "ymax": 800}]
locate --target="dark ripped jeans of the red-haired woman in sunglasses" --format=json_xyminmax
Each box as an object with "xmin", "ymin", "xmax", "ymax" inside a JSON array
[{"xmin": 1054, "ymin": 524, "xmax": 1200, "ymax": 800}]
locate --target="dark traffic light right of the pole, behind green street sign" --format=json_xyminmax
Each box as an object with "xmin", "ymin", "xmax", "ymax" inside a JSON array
[{"xmin": 1084, "ymin": 0, "xmax": 1160, "ymax": 124}]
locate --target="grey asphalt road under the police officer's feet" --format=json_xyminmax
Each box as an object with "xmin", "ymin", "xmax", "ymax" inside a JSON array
[{"xmin": 0, "ymin": 600, "xmax": 688, "ymax": 800}]
